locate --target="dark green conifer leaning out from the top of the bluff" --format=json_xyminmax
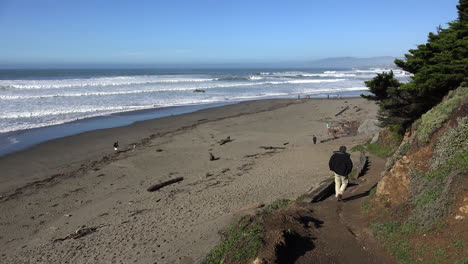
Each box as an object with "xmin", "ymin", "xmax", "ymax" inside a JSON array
[{"xmin": 363, "ymin": 0, "xmax": 468, "ymax": 128}]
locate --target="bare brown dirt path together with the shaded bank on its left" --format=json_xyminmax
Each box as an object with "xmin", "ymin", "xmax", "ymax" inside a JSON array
[{"xmin": 257, "ymin": 155, "xmax": 396, "ymax": 264}]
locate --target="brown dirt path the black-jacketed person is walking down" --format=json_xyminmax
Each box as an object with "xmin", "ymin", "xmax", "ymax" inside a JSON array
[{"xmin": 294, "ymin": 155, "xmax": 396, "ymax": 264}]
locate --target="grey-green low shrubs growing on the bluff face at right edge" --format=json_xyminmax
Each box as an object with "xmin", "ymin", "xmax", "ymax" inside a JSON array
[{"xmin": 409, "ymin": 114, "xmax": 468, "ymax": 230}]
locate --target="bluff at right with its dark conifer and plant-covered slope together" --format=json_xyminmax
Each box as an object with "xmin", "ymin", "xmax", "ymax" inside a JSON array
[{"xmin": 361, "ymin": 0, "xmax": 468, "ymax": 263}]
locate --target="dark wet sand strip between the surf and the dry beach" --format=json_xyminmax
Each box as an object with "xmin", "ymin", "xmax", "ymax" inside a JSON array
[{"xmin": 0, "ymin": 99, "xmax": 304, "ymax": 195}]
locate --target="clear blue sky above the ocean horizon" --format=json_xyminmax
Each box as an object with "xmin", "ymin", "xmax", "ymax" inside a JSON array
[{"xmin": 0, "ymin": 0, "xmax": 458, "ymax": 67}]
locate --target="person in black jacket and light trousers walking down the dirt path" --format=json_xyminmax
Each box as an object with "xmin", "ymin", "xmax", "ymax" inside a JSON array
[{"xmin": 328, "ymin": 146, "xmax": 353, "ymax": 201}]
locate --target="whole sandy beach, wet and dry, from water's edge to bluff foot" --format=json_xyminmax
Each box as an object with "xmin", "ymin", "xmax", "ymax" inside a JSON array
[{"xmin": 0, "ymin": 98, "xmax": 377, "ymax": 263}]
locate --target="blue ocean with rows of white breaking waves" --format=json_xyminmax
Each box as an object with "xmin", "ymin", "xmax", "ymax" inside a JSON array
[{"xmin": 0, "ymin": 68, "xmax": 409, "ymax": 155}]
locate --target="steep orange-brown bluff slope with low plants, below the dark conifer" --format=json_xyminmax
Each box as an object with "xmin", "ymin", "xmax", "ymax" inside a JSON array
[{"xmin": 370, "ymin": 87, "xmax": 468, "ymax": 263}]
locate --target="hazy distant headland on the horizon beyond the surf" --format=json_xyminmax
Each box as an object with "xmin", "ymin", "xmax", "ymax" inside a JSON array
[{"xmin": 306, "ymin": 56, "xmax": 396, "ymax": 68}]
